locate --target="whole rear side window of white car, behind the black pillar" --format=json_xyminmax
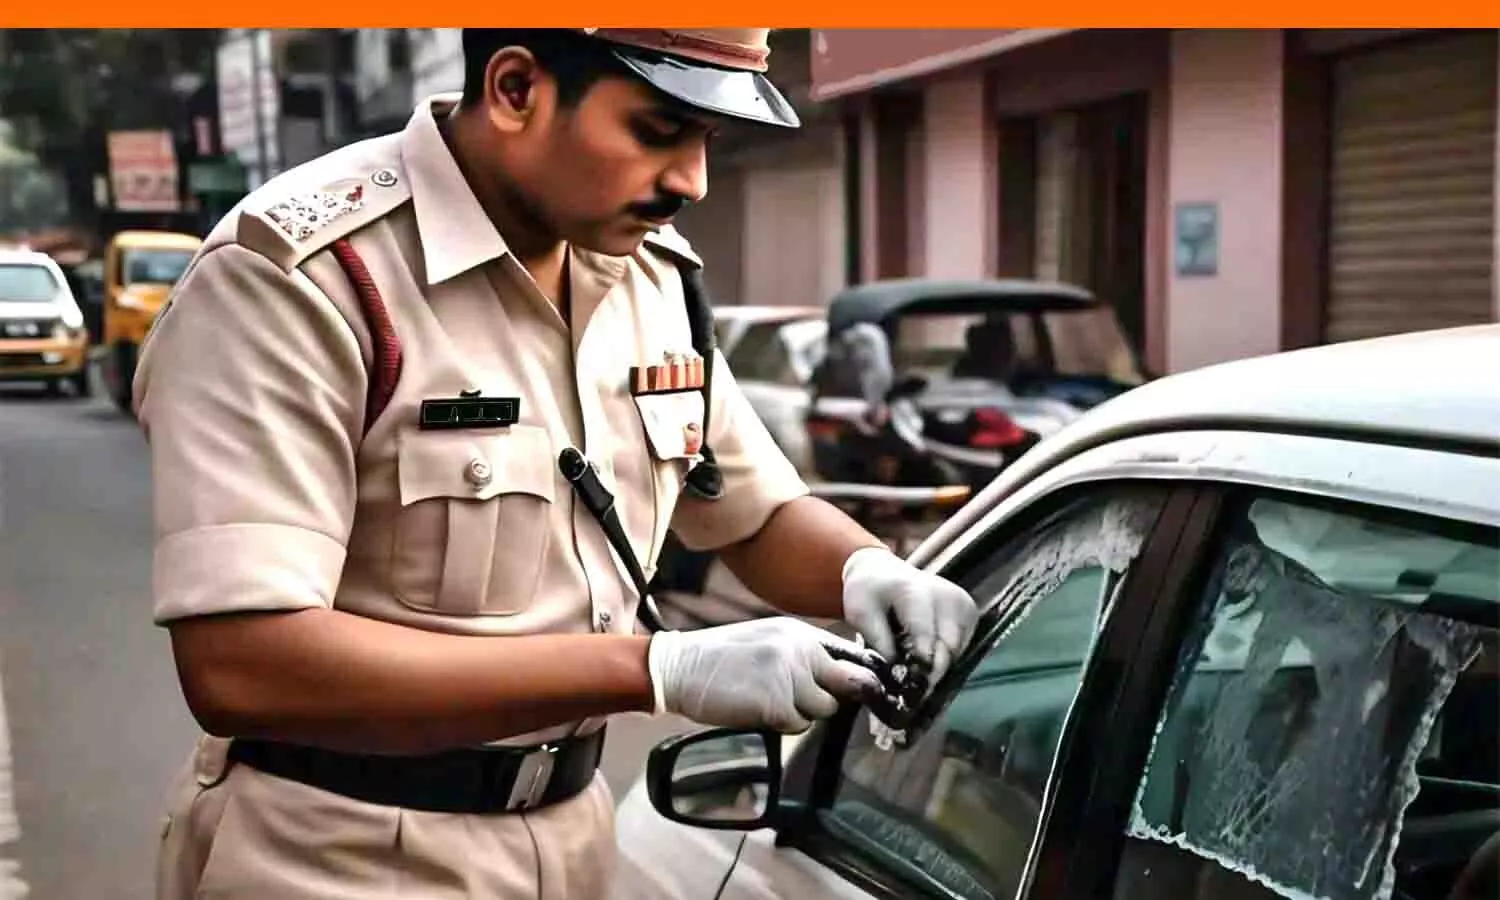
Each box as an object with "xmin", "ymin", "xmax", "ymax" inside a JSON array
[{"xmin": 1115, "ymin": 494, "xmax": 1500, "ymax": 900}]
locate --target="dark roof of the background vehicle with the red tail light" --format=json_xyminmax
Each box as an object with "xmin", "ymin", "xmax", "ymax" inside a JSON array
[{"xmin": 828, "ymin": 278, "xmax": 1100, "ymax": 335}]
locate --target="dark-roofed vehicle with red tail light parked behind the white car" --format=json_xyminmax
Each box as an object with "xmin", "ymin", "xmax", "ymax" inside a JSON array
[{"xmin": 806, "ymin": 278, "xmax": 1146, "ymax": 491}]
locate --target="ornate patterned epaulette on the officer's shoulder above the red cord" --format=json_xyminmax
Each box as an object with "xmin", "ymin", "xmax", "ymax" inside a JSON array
[{"xmin": 236, "ymin": 168, "xmax": 411, "ymax": 272}]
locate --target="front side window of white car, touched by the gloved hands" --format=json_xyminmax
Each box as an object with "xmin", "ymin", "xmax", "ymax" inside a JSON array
[{"xmin": 821, "ymin": 488, "xmax": 1164, "ymax": 900}]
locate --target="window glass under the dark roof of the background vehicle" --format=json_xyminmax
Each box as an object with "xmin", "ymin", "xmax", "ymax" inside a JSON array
[{"xmin": 891, "ymin": 308, "xmax": 1146, "ymax": 386}]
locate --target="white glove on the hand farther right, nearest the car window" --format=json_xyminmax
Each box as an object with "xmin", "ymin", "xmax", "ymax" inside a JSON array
[{"xmin": 843, "ymin": 548, "xmax": 980, "ymax": 684}]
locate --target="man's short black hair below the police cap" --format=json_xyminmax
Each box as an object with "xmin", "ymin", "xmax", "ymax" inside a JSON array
[{"xmin": 464, "ymin": 29, "xmax": 630, "ymax": 107}]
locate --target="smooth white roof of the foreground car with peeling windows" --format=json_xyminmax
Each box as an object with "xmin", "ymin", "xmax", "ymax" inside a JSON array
[{"xmin": 1017, "ymin": 324, "xmax": 1500, "ymax": 471}]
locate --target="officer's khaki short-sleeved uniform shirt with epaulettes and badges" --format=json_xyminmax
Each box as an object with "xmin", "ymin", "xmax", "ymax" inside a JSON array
[{"xmin": 135, "ymin": 96, "xmax": 807, "ymax": 743}]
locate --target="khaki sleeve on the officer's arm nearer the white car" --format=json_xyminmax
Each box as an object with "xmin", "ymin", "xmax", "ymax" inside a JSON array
[{"xmin": 672, "ymin": 351, "xmax": 807, "ymax": 551}]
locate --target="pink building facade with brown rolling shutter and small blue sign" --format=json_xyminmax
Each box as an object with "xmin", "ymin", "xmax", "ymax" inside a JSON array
[{"xmin": 812, "ymin": 30, "xmax": 1500, "ymax": 371}]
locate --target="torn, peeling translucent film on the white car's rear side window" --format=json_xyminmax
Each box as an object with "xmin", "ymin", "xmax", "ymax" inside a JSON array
[{"xmin": 1128, "ymin": 501, "xmax": 1500, "ymax": 900}]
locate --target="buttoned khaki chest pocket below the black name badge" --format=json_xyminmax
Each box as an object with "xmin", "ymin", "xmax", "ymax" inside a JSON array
[{"xmin": 390, "ymin": 425, "xmax": 555, "ymax": 615}]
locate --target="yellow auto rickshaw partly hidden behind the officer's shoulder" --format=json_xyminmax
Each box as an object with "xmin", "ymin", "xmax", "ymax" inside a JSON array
[{"xmin": 101, "ymin": 230, "xmax": 203, "ymax": 413}]
